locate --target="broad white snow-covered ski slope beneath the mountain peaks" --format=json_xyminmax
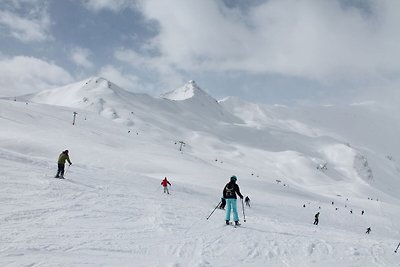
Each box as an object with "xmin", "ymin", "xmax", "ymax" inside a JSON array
[{"xmin": 0, "ymin": 78, "xmax": 400, "ymax": 267}]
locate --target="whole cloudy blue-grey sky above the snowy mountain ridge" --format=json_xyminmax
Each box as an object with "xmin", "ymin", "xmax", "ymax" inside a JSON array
[{"xmin": 0, "ymin": 0, "xmax": 400, "ymax": 104}]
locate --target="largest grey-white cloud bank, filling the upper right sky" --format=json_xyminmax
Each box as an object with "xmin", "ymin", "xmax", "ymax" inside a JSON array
[{"xmin": 134, "ymin": 0, "xmax": 400, "ymax": 85}]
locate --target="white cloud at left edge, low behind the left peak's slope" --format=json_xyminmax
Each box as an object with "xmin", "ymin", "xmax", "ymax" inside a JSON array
[{"xmin": 0, "ymin": 56, "xmax": 73, "ymax": 96}]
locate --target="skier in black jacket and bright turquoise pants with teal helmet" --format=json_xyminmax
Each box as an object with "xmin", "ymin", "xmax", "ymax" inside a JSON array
[{"xmin": 223, "ymin": 175, "xmax": 243, "ymax": 225}]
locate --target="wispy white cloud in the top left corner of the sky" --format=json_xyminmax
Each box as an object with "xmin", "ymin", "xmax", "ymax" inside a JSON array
[{"xmin": 0, "ymin": 0, "xmax": 51, "ymax": 42}]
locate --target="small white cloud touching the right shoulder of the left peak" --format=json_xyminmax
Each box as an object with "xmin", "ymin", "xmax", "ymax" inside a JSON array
[{"xmin": 98, "ymin": 65, "xmax": 142, "ymax": 91}]
